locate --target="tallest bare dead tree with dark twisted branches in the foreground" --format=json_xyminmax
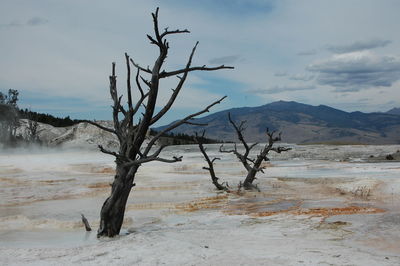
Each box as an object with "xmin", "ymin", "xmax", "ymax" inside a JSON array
[{"xmin": 87, "ymin": 8, "xmax": 233, "ymax": 237}]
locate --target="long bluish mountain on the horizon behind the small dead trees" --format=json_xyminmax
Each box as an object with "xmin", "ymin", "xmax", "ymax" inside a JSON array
[{"xmin": 156, "ymin": 101, "xmax": 400, "ymax": 144}]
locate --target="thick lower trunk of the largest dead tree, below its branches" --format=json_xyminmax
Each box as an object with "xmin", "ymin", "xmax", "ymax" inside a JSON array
[{"xmin": 97, "ymin": 164, "xmax": 138, "ymax": 237}]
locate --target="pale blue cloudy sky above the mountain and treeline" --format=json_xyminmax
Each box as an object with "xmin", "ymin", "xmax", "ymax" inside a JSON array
[{"xmin": 0, "ymin": 0, "xmax": 400, "ymax": 123}]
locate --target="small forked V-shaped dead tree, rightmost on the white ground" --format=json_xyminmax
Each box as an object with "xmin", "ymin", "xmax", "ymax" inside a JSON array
[{"xmin": 219, "ymin": 113, "xmax": 291, "ymax": 189}]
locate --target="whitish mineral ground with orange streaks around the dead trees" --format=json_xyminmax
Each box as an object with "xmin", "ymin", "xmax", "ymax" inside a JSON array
[{"xmin": 0, "ymin": 146, "xmax": 400, "ymax": 265}]
